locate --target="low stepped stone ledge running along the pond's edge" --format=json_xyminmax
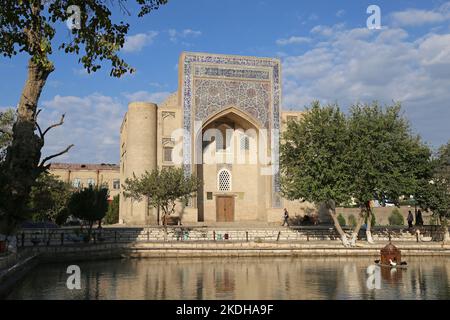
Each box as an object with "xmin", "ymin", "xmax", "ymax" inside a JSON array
[{"xmin": 23, "ymin": 241, "xmax": 450, "ymax": 262}]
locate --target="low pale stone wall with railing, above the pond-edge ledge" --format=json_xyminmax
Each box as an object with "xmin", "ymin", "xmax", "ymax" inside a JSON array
[{"xmin": 17, "ymin": 226, "xmax": 443, "ymax": 248}]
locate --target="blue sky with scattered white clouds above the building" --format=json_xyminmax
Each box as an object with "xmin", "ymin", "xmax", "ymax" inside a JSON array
[{"xmin": 0, "ymin": 0, "xmax": 450, "ymax": 163}]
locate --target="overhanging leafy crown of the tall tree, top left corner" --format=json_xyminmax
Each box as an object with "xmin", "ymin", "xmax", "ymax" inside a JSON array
[{"xmin": 0, "ymin": 0, "xmax": 167, "ymax": 77}]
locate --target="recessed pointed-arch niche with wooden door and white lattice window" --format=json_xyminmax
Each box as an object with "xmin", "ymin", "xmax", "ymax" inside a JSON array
[{"xmin": 195, "ymin": 107, "xmax": 266, "ymax": 222}]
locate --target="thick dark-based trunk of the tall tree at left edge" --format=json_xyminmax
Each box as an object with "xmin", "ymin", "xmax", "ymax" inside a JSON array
[{"xmin": 3, "ymin": 59, "xmax": 53, "ymax": 228}]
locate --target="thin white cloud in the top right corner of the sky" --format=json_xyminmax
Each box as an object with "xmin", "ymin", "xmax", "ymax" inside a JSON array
[{"xmin": 390, "ymin": 2, "xmax": 450, "ymax": 27}]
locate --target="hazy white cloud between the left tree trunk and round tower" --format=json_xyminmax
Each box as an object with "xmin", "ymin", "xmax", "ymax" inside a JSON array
[{"xmin": 39, "ymin": 93, "xmax": 126, "ymax": 163}]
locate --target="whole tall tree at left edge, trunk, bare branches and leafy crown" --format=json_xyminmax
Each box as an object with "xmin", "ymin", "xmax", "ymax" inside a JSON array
[{"xmin": 0, "ymin": 0, "xmax": 167, "ymax": 239}]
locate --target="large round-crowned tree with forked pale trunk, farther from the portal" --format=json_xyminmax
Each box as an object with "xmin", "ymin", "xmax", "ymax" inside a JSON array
[{"xmin": 346, "ymin": 102, "xmax": 431, "ymax": 243}]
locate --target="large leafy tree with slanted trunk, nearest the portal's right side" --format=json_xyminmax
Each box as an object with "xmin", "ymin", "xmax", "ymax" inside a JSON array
[{"xmin": 280, "ymin": 102, "xmax": 350, "ymax": 246}]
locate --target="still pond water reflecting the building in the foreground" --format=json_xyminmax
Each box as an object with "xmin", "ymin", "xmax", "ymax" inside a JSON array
[{"xmin": 8, "ymin": 257, "xmax": 450, "ymax": 300}]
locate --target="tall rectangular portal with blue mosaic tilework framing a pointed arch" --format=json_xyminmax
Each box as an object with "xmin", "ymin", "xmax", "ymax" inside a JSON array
[{"xmin": 179, "ymin": 52, "xmax": 282, "ymax": 222}]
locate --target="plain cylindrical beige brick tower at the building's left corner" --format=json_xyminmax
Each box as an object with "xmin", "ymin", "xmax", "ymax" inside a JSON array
[{"xmin": 120, "ymin": 102, "xmax": 158, "ymax": 225}]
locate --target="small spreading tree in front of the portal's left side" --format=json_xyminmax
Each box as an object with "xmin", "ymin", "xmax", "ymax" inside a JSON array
[{"xmin": 123, "ymin": 167, "xmax": 200, "ymax": 226}]
